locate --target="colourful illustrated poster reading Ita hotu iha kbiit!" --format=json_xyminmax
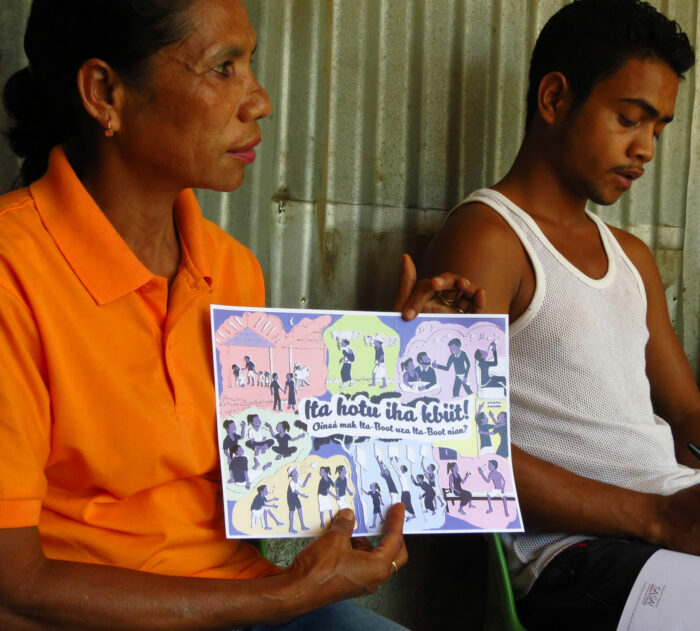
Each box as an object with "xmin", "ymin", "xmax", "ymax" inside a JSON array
[{"xmin": 211, "ymin": 305, "xmax": 522, "ymax": 538}]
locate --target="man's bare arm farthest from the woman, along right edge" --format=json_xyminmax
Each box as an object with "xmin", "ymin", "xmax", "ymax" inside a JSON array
[{"xmin": 614, "ymin": 230, "xmax": 700, "ymax": 469}]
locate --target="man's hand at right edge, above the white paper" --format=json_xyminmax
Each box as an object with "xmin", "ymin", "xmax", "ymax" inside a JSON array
[{"xmin": 649, "ymin": 484, "xmax": 700, "ymax": 555}]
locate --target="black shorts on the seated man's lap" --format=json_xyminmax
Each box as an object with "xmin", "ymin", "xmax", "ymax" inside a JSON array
[{"xmin": 517, "ymin": 538, "xmax": 659, "ymax": 631}]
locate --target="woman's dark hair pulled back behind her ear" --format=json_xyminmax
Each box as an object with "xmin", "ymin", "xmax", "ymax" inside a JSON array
[{"xmin": 3, "ymin": 0, "xmax": 192, "ymax": 184}]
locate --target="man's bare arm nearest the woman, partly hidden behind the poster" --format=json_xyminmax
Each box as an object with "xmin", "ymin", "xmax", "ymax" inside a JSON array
[{"xmin": 418, "ymin": 204, "xmax": 700, "ymax": 554}]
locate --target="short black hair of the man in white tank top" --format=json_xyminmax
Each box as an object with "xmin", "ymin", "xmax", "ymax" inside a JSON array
[{"xmin": 526, "ymin": 0, "xmax": 695, "ymax": 126}]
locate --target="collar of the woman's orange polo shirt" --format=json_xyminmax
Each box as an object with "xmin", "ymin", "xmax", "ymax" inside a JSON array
[{"xmin": 29, "ymin": 147, "xmax": 211, "ymax": 304}]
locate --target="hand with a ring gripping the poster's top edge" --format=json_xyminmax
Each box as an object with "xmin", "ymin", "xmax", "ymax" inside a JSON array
[{"xmin": 394, "ymin": 254, "xmax": 486, "ymax": 320}]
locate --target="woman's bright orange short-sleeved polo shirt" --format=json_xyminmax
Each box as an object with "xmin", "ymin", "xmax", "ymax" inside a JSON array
[{"xmin": 0, "ymin": 148, "xmax": 275, "ymax": 578}]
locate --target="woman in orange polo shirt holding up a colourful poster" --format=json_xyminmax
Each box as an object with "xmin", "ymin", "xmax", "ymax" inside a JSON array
[{"xmin": 0, "ymin": 0, "xmax": 406, "ymax": 631}]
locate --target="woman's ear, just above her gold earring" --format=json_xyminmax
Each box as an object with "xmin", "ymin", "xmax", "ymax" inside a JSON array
[{"xmin": 77, "ymin": 58, "xmax": 124, "ymax": 132}]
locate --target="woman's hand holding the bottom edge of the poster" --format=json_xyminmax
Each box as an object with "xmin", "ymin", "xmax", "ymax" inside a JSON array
[{"xmin": 287, "ymin": 504, "xmax": 408, "ymax": 606}]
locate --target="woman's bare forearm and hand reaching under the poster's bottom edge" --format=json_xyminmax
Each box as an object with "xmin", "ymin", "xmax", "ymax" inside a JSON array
[{"xmin": 0, "ymin": 505, "xmax": 407, "ymax": 631}]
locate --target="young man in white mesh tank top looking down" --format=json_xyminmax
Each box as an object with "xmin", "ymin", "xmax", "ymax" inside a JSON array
[{"xmin": 412, "ymin": 0, "xmax": 700, "ymax": 630}]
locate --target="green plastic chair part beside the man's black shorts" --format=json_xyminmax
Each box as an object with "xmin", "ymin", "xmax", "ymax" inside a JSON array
[{"xmin": 484, "ymin": 533, "xmax": 526, "ymax": 631}]
